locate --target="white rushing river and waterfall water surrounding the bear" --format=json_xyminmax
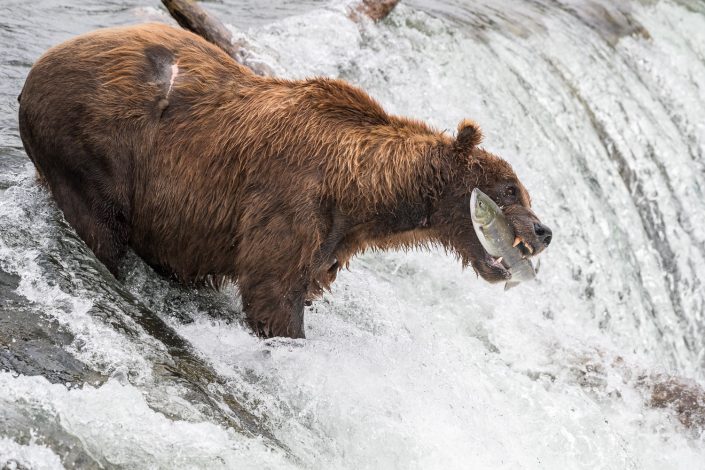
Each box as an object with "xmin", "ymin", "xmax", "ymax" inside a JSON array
[{"xmin": 0, "ymin": 0, "xmax": 705, "ymax": 469}]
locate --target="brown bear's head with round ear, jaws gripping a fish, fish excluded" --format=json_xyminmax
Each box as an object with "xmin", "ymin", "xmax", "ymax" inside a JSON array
[{"xmin": 434, "ymin": 120, "xmax": 552, "ymax": 282}]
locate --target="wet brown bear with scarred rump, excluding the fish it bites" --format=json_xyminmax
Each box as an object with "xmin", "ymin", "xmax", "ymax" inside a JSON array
[{"xmin": 19, "ymin": 24, "xmax": 551, "ymax": 338}]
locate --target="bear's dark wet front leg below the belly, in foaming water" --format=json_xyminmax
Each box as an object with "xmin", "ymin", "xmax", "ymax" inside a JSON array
[{"xmin": 240, "ymin": 276, "xmax": 306, "ymax": 338}]
